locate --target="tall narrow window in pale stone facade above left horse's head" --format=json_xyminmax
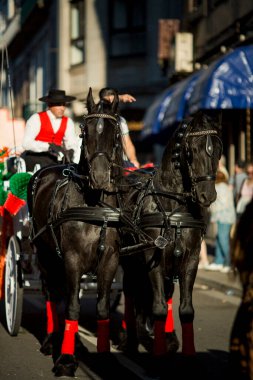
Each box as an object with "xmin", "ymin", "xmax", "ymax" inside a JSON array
[{"xmin": 70, "ymin": 0, "xmax": 84, "ymax": 66}]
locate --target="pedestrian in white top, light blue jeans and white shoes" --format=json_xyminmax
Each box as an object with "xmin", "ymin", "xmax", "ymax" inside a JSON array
[{"xmin": 205, "ymin": 169, "xmax": 236, "ymax": 273}]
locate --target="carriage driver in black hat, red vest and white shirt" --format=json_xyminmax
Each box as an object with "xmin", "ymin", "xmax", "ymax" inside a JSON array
[{"xmin": 21, "ymin": 89, "xmax": 80, "ymax": 171}]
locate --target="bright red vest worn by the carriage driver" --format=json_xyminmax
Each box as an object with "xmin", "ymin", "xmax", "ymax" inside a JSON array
[{"xmin": 35, "ymin": 112, "xmax": 68, "ymax": 145}]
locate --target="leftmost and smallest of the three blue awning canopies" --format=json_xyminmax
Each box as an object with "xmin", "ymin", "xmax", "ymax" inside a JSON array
[{"xmin": 140, "ymin": 86, "xmax": 175, "ymax": 139}]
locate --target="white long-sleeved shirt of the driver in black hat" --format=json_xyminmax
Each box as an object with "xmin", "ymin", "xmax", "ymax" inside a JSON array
[{"xmin": 22, "ymin": 110, "xmax": 80, "ymax": 163}]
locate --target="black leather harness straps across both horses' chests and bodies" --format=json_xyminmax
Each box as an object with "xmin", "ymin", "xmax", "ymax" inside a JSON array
[{"xmin": 32, "ymin": 166, "xmax": 206, "ymax": 257}]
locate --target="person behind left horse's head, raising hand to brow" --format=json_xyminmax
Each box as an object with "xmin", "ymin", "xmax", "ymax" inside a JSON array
[{"xmin": 99, "ymin": 87, "xmax": 140, "ymax": 168}]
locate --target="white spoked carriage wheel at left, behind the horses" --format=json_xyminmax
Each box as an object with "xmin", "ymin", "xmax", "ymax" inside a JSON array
[{"xmin": 4, "ymin": 236, "xmax": 23, "ymax": 336}]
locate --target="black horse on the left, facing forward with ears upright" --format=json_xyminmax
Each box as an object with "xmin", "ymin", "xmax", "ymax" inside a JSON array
[{"xmin": 28, "ymin": 89, "xmax": 123, "ymax": 376}]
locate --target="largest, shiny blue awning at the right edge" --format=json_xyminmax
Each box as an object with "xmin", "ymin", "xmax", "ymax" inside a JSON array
[{"xmin": 188, "ymin": 45, "xmax": 253, "ymax": 114}]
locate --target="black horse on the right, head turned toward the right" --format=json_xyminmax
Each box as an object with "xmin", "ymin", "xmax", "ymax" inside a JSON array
[{"xmin": 121, "ymin": 112, "xmax": 222, "ymax": 356}]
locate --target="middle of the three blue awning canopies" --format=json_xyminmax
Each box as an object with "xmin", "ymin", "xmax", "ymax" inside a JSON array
[{"xmin": 161, "ymin": 71, "xmax": 201, "ymax": 129}]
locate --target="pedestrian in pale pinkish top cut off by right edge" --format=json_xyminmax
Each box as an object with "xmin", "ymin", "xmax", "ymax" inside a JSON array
[{"xmin": 236, "ymin": 162, "xmax": 253, "ymax": 219}]
